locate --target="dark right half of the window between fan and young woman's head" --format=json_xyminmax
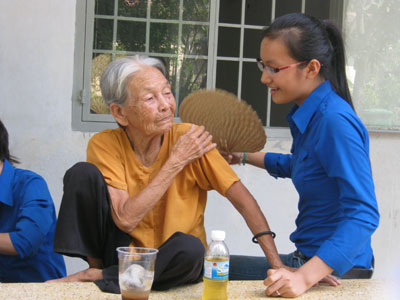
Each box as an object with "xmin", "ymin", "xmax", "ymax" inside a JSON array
[{"xmin": 212, "ymin": 0, "xmax": 342, "ymax": 128}]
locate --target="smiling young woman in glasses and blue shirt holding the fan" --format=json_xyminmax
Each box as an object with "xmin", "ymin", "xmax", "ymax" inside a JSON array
[{"xmin": 223, "ymin": 13, "xmax": 379, "ymax": 297}]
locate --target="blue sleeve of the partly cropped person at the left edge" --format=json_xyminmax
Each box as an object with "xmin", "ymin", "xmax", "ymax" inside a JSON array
[{"xmin": 10, "ymin": 176, "xmax": 55, "ymax": 258}]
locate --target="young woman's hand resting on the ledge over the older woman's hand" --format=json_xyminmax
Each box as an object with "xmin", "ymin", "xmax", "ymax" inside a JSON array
[{"xmin": 264, "ymin": 268, "xmax": 308, "ymax": 298}]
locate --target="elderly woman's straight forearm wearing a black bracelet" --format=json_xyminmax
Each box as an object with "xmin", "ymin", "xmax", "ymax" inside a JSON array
[{"xmin": 226, "ymin": 181, "xmax": 284, "ymax": 269}]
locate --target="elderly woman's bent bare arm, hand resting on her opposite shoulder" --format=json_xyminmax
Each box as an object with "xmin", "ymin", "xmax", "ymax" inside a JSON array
[{"xmin": 108, "ymin": 125, "xmax": 216, "ymax": 233}]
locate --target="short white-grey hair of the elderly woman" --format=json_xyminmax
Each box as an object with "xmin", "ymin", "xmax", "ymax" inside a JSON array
[{"xmin": 100, "ymin": 55, "xmax": 166, "ymax": 107}]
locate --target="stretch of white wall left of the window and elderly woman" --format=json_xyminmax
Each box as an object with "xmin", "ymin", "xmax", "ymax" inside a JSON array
[{"xmin": 0, "ymin": 0, "xmax": 89, "ymax": 276}]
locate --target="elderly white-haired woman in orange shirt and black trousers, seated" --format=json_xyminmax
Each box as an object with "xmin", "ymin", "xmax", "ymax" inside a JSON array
[{"xmin": 55, "ymin": 56, "xmax": 282, "ymax": 290}]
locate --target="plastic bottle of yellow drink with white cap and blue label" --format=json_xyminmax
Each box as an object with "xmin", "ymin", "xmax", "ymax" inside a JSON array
[{"xmin": 202, "ymin": 230, "xmax": 229, "ymax": 300}]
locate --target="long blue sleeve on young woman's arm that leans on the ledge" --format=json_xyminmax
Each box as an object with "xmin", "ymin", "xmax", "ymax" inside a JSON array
[{"xmin": 316, "ymin": 113, "xmax": 379, "ymax": 275}]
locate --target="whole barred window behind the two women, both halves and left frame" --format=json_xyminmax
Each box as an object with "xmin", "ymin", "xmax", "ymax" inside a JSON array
[{"xmin": 72, "ymin": 0, "xmax": 343, "ymax": 131}]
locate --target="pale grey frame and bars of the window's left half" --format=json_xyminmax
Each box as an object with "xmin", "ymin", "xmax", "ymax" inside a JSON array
[{"xmin": 72, "ymin": 0, "xmax": 218, "ymax": 132}]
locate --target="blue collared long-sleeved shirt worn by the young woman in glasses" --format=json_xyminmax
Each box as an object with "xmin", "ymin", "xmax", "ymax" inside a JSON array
[{"xmin": 264, "ymin": 81, "xmax": 379, "ymax": 275}]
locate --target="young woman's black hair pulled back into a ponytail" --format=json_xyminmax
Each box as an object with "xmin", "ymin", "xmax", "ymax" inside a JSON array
[{"xmin": 263, "ymin": 13, "xmax": 354, "ymax": 109}]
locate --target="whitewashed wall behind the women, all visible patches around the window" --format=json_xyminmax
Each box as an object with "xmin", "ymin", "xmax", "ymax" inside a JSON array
[{"xmin": 0, "ymin": 0, "xmax": 400, "ymax": 277}]
